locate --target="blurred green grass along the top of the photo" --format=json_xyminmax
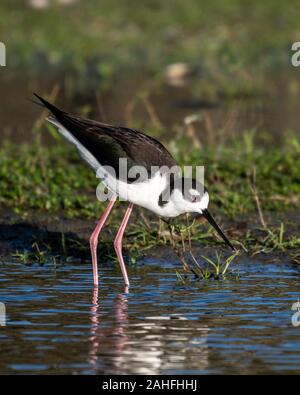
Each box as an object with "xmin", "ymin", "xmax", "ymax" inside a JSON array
[{"xmin": 0, "ymin": 0, "xmax": 298, "ymax": 95}]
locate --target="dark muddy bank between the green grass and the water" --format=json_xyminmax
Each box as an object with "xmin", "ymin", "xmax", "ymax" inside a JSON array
[{"xmin": 0, "ymin": 207, "xmax": 300, "ymax": 261}]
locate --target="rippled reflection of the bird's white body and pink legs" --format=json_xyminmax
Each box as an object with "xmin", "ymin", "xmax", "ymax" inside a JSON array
[{"xmin": 88, "ymin": 282, "xmax": 210, "ymax": 374}]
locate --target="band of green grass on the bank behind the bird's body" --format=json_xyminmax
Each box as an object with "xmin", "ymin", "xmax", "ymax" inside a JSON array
[{"xmin": 0, "ymin": 130, "xmax": 300, "ymax": 218}]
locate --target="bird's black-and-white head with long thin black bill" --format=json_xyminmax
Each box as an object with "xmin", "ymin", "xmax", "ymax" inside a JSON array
[{"xmin": 171, "ymin": 177, "xmax": 235, "ymax": 250}]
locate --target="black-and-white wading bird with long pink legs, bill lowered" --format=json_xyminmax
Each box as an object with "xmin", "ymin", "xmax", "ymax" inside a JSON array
[{"xmin": 34, "ymin": 93, "xmax": 235, "ymax": 287}]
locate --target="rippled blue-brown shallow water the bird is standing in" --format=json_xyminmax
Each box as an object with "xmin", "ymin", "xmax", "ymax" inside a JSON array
[{"xmin": 0, "ymin": 259, "xmax": 300, "ymax": 374}]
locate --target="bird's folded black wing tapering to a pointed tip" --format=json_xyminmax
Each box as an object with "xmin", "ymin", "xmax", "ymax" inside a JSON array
[{"xmin": 35, "ymin": 94, "xmax": 176, "ymax": 183}]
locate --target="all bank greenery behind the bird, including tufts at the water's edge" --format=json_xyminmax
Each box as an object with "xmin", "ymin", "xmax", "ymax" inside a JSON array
[{"xmin": 0, "ymin": 133, "xmax": 300, "ymax": 270}]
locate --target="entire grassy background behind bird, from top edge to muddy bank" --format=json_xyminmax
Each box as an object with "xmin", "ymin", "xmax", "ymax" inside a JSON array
[{"xmin": 0, "ymin": 0, "xmax": 300, "ymax": 220}]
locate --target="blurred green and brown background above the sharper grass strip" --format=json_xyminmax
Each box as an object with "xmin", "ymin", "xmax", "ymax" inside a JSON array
[{"xmin": 0, "ymin": 0, "xmax": 300, "ymax": 144}]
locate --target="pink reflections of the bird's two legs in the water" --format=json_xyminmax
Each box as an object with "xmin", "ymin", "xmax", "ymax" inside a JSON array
[{"xmin": 88, "ymin": 287, "xmax": 128, "ymax": 372}]
